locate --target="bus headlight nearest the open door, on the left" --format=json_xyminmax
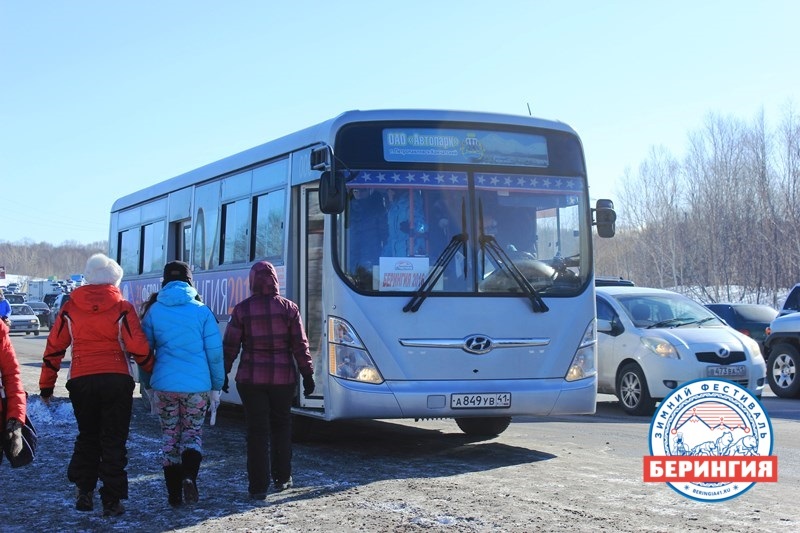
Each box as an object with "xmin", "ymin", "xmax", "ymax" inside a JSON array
[{"xmin": 328, "ymin": 317, "xmax": 383, "ymax": 384}]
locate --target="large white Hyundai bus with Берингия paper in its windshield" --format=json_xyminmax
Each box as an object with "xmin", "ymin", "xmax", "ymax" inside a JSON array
[{"xmin": 109, "ymin": 110, "xmax": 615, "ymax": 435}]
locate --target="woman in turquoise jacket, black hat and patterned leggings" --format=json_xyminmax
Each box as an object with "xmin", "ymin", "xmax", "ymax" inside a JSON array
[{"xmin": 142, "ymin": 261, "xmax": 225, "ymax": 506}]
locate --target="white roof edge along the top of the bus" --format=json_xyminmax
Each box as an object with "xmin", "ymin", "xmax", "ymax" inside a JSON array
[{"xmin": 111, "ymin": 109, "xmax": 575, "ymax": 212}]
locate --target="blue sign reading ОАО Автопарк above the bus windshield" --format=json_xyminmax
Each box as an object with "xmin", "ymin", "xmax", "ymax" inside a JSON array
[{"xmin": 383, "ymin": 128, "xmax": 549, "ymax": 168}]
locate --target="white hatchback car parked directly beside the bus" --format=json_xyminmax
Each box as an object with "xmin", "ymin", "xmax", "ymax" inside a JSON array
[{"xmin": 596, "ymin": 287, "xmax": 766, "ymax": 415}]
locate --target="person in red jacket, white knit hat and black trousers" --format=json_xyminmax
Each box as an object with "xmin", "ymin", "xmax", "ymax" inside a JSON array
[{"xmin": 39, "ymin": 254, "xmax": 154, "ymax": 516}]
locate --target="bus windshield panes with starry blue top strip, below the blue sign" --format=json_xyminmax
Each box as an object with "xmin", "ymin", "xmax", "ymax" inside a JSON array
[{"xmin": 338, "ymin": 175, "xmax": 589, "ymax": 295}]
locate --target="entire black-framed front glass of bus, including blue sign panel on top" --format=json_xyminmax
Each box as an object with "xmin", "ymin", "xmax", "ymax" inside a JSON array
[{"xmin": 334, "ymin": 123, "xmax": 591, "ymax": 296}]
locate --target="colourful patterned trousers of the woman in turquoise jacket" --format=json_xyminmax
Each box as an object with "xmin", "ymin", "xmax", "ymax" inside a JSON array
[{"xmin": 155, "ymin": 391, "xmax": 209, "ymax": 466}]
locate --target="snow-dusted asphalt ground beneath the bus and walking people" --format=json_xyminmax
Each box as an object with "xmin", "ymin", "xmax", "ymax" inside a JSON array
[{"xmin": 6, "ymin": 335, "xmax": 800, "ymax": 533}]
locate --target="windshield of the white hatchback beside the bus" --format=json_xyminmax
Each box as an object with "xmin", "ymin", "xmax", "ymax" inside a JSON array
[{"xmin": 616, "ymin": 294, "xmax": 721, "ymax": 328}]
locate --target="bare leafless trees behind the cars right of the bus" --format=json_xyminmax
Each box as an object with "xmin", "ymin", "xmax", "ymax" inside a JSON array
[{"xmin": 595, "ymin": 105, "xmax": 800, "ymax": 307}]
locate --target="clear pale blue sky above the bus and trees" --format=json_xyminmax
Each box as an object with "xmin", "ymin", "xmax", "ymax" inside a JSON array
[{"xmin": 0, "ymin": 0, "xmax": 800, "ymax": 244}]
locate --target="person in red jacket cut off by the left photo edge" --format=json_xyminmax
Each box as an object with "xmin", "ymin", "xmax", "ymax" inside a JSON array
[{"xmin": 0, "ymin": 321, "xmax": 27, "ymax": 461}]
